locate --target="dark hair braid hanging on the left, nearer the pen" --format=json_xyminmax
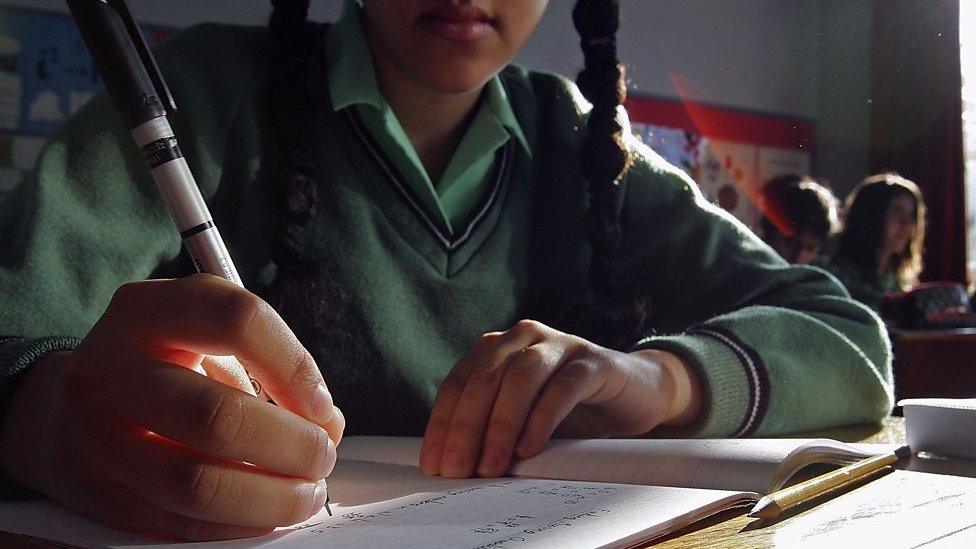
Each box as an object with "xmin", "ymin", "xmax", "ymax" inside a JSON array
[{"xmin": 260, "ymin": 0, "xmax": 438, "ymax": 434}]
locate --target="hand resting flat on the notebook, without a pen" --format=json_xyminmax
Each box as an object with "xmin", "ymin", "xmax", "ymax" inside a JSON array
[{"xmin": 420, "ymin": 320, "xmax": 701, "ymax": 478}]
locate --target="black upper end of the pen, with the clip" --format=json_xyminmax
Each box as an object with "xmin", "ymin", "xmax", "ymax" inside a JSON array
[{"xmin": 67, "ymin": 0, "xmax": 166, "ymax": 128}]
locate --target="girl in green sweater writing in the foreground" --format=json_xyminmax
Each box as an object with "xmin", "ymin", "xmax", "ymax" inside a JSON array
[{"xmin": 0, "ymin": 0, "xmax": 892, "ymax": 540}]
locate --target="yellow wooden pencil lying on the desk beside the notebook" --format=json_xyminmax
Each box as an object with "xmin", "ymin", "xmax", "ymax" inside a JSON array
[{"xmin": 749, "ymin": 446, "xmax": 910, "ymax": 519}]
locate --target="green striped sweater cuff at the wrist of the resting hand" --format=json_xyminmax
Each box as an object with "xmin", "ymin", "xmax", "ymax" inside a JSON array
[{"xmin": 631, "ymin": 326, "xmax": 769, "ymax": 438}]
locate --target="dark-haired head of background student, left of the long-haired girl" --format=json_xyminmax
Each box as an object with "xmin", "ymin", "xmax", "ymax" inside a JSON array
[{"xmin": 761, "ymin": 175, "xmax": 840, "ymax": 265}]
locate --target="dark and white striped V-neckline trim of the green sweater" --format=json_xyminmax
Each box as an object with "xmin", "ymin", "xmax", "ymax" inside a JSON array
[{"xmin": 342, "ymin": 108, "xmax": 513, "ymax": 252}]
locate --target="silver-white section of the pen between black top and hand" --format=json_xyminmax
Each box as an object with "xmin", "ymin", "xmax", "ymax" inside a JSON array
[{"xmin": 132, "ymin": 116, "xmax": 243, "ymax": 286}]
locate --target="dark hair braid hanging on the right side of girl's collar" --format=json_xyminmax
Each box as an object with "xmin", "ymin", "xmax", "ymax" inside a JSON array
[{"xmin": 573, "ymin": 0, "xmax": 648, "ymax": 348}]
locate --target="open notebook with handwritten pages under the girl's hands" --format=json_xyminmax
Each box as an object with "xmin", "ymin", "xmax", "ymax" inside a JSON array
[{"xmin": 0, "ymin": 437, "xmax": 891, "ymax": 549}]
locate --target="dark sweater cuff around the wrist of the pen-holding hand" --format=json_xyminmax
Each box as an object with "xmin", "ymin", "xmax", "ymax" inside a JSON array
[{"xmin": 0, "ymin": 336, "xmax": 81, "ymax": 501}]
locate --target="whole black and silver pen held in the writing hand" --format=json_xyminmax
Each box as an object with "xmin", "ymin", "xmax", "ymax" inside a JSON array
[{"xmin": 67, "ymin": 0, "xmax": 332, "ymax": 516}]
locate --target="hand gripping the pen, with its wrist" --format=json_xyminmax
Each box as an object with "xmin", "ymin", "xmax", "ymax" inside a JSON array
[{"xmin": 0, "ymin": 275, "xmax": 345, "ymax": 540}]
